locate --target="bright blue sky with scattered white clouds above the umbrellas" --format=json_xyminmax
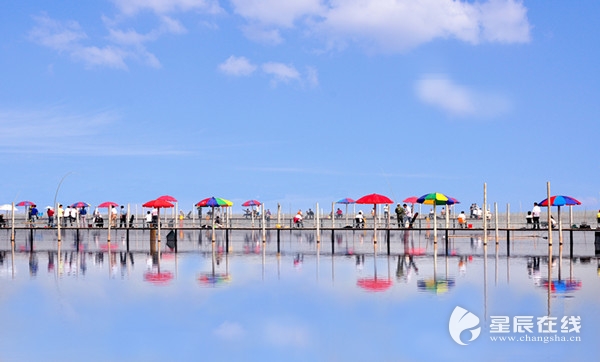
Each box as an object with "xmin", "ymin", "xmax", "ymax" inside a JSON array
[{"xmin": 0, "ymin": 0, "xmax": 600, "ymax": 212}]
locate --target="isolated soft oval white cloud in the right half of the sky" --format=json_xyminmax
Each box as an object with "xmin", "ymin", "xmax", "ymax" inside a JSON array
[{"xmin": 415, "ymin": 75, "xmax": 511, "ymax": 118}]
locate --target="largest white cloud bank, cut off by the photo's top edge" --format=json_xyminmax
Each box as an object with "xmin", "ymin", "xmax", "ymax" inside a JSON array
[{"xmin": 232, "ymin": 0, "xmax": 530, "ymax": 52}]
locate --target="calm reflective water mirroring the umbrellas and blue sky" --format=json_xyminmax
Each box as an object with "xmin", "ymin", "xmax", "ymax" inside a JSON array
[{"xmin": 0, "ymin": 230, "xmax": 600, "ymax": 361}]
